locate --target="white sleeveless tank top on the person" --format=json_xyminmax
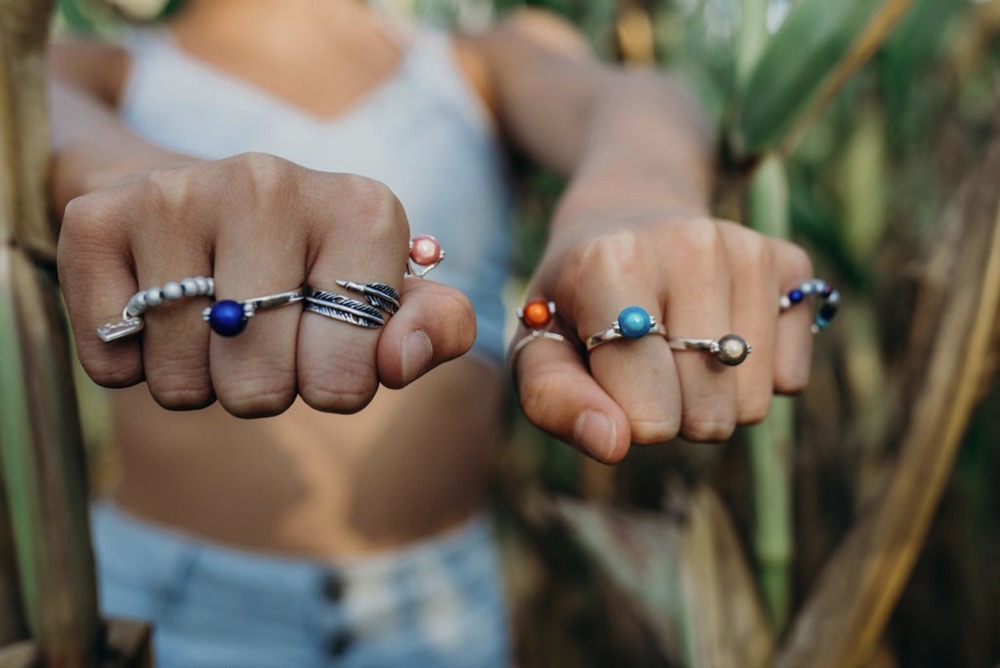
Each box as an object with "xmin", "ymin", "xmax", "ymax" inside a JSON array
[{"xmin": 121, "ymin": 24, "xmax": 511, "ymax": 361}]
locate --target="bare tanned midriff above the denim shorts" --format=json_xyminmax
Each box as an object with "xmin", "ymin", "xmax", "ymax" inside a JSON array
[{"xmin": 107, "ymin": 357, "xmax": 502, "ymax": 557}]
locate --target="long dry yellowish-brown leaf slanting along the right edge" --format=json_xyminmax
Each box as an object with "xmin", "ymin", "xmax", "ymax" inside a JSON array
[{"xmin": 777, "ymin": 137, "xmax": 1000, "ymax": 668}]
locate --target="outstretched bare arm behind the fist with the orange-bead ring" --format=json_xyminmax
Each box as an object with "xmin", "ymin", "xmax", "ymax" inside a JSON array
[{"xmin": 474, "ymin": 21, "xmax": 713, "ymax": 227}]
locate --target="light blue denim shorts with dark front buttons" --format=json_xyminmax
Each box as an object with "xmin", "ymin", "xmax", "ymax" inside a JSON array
[{"xmin": 91, "ymin": 502, "xmax": 511, "ymax": 668}]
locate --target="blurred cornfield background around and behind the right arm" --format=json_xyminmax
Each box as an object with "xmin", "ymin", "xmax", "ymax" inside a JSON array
[{"xmin": 15, "ymin": 0, "xmax": 1000, "ymax": 666}]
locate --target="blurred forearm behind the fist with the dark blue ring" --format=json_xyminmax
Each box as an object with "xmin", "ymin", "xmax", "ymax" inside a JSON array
[{"xmin": 49, "ymin": 79, "xmax": 193, "ymax": 211}]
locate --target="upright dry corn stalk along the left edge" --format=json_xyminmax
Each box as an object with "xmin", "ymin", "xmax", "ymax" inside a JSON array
[{"xmin": 0, "ymin": 0, "xmax": 98, "ymax": 667}]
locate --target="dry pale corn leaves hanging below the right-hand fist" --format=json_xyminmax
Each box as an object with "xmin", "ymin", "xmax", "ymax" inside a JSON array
[{"xmin": 552, "ymin": 484, "xmax": 773, "ymax": 668}]
